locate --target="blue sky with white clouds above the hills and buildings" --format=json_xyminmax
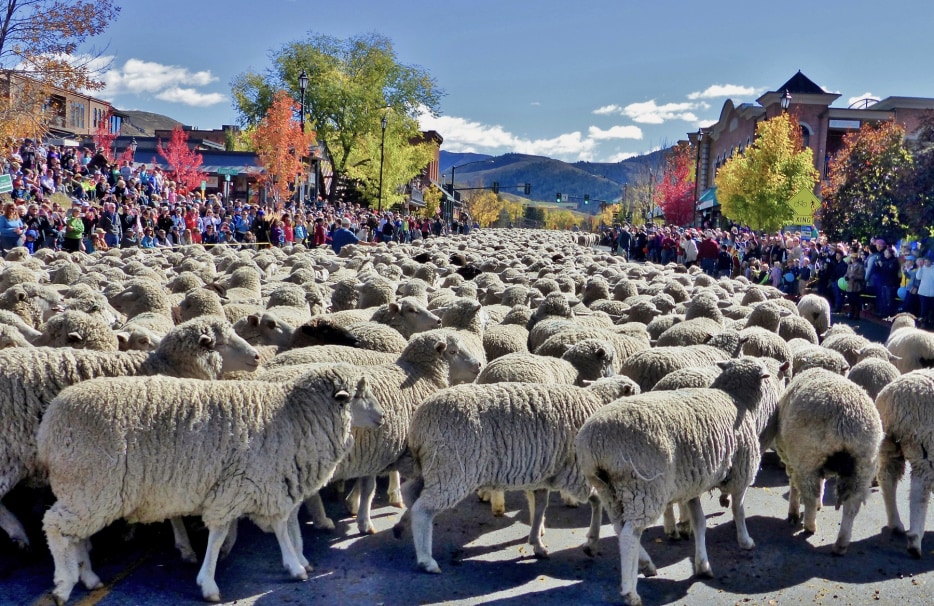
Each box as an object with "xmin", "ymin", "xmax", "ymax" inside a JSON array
[{"xmin": 94, "ymin": 0, "xmax": 934, "ymax": 162}]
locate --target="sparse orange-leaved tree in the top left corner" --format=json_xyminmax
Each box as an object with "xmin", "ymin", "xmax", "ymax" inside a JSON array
[{"xmin": 0, "ymin": 0, "xmax": 120, "ymax": 137}]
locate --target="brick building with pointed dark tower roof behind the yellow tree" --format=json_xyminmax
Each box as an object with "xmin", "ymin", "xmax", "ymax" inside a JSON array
[{"xmin": 688, "ymin": 71, "xmax": 934, "ymax": 224}]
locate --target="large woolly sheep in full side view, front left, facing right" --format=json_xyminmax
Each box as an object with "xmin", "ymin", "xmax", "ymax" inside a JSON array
[{"xmin": 38, "ymin": 365, "xmax": 383, "ymax": 603}]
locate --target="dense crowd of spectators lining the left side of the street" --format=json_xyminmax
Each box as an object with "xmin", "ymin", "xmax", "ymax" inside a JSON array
[{"xmin": 0, "ymin": 139, "xmax": 477, "ymax": 254}]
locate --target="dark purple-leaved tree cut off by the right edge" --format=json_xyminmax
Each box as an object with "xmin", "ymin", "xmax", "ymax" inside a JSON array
[{"xmin": 899, "ymin": 111, "xmax": 934, "ymax": 237}]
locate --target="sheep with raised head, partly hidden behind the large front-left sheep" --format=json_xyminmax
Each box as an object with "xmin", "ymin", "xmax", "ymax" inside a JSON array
[{"xmin": 307, "ymin": 329, "xmax": 481, "ymax": 534}]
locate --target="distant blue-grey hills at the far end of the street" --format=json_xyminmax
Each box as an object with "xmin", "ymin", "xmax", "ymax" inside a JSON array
[{"xmin": 440, "ymin": 151, "xmax": 664, "ymax": 202}]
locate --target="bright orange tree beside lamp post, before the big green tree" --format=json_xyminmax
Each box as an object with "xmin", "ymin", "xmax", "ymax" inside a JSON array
[{"xmin": 253, "ymin": 90, "xmax": 315, "ymax": 205}]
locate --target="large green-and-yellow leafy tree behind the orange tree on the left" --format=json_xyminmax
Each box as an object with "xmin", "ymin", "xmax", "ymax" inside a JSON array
[{"xmin": 231, "ymin": 34, "xmax": 443, "ymax": 202}]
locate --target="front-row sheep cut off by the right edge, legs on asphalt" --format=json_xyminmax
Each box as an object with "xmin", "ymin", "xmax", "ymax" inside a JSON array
[{"xmin": 876, "ymin": 369, "xmax": 934, "ymax": 558}]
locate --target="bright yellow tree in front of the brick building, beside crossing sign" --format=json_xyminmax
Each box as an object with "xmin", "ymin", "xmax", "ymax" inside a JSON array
[{"xmin": 715, "ymin": 113, "xmax": 820, "ymax": 231}]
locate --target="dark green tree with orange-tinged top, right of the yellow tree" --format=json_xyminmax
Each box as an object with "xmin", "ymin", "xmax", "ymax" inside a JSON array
[{"xmin": 819, "ymin": 120, "xmax": 911, "ymax": 242}]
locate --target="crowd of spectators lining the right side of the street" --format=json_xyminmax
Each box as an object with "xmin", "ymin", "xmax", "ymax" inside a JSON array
[{"xmin": 603, "ymin": 224, "xmax": 934, "ymax": 328}]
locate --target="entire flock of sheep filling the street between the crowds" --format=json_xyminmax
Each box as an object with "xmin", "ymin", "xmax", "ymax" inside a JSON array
[{"xmin": 0, "ymin": 230, "xmax": 934, "ymax": 604}]
